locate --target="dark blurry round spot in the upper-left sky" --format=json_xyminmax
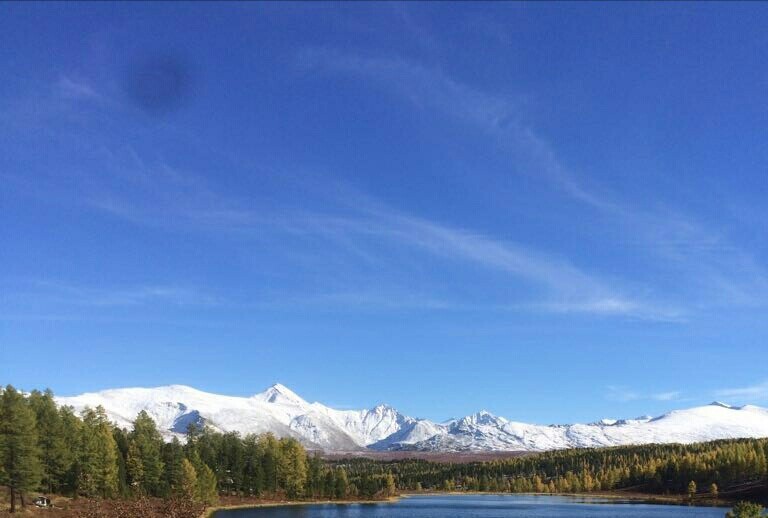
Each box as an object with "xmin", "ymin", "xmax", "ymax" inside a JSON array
[{"xmin": 124, "ymin": 54, "xmax": 192, "ymax": 116}]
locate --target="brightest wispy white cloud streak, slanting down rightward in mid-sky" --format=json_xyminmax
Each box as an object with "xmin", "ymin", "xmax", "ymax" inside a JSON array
[{"xmin": 228, "ymin": 191, "xmax": 684, "ymax": 321}]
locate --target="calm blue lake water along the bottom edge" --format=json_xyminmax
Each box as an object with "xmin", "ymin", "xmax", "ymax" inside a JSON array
[{"xmin": 214, "ymin": 495, "xmax": 726, "ymax": 518}]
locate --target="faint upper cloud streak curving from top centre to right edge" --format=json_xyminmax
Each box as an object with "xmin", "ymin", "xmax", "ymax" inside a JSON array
[{"xmin": 299, "ymin": 48, "xmax": 768, "ymax": 311}]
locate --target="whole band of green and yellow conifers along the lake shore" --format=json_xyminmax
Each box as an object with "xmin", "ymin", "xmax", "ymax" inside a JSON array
[{"xmin": 0, "ymin": 386, "xmax": 768, "ymax": 518}]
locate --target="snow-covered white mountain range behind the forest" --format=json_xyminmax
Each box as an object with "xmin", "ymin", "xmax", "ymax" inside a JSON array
[{"xmin": 57, "ymin": 384, "xmax": 768, "ymax": 452}]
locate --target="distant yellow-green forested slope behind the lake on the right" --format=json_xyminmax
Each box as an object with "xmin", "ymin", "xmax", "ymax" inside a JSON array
[{"xmin": 339, "ymin": 439, "xmax": 768, "ymax": 498}]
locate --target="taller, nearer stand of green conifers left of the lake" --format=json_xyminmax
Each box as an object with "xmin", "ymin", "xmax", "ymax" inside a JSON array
[{"xmin": 0, "ymin": 386, "xmax": 366, "ymax": 508}]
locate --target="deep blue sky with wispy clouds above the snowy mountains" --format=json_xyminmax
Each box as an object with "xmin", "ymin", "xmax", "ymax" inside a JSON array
[{"xmin": 0, "ymin": 2, "xmax": 768, "ymax": 423}]
